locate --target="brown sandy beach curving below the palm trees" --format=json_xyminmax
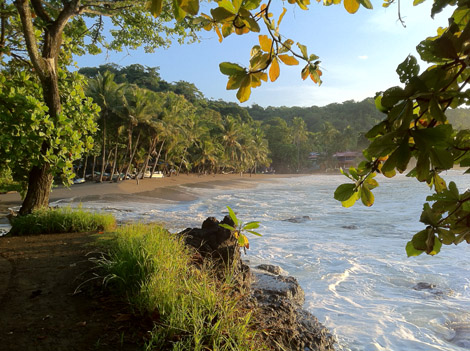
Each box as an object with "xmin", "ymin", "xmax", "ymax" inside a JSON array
[{"xmin": 0, "ymin": 174, "xmax": 297, "ymax": 216}]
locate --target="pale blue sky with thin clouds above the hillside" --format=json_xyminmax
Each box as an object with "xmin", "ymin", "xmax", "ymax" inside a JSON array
[{"xmin": 72, "ymin": 0, "xmax": 451, "ymax": 107}]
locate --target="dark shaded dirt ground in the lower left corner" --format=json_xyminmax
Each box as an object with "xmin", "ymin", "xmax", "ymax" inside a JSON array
[{"xmin": 0, "ymin": 233, "xmax": 147, "ymax": 351}]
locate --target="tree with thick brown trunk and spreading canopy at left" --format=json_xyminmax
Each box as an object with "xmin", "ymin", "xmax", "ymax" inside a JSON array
[{"xmin": 0, "ymin": 0, "xmax": 194, "ymax": 214}]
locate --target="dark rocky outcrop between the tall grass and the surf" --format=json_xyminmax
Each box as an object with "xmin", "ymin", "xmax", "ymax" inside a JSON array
[{"xmin": 179, "ymin": 216, "xmax": 335, "ymax": 351}]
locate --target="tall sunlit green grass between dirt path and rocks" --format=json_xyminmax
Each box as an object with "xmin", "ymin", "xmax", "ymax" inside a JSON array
[{"xmin": 98, "ymin": 224, "xmax": 263, "ymax": 351}]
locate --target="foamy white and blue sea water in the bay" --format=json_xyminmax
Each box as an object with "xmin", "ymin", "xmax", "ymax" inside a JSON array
[{"xmin": 51, "ymin": 171, "xmax": 470, "ymax": 351}]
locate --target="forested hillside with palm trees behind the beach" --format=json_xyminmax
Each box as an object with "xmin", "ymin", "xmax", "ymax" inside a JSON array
[{"xmin": 75, "ymin": 64, "xmax": 468, "ymax": 174}]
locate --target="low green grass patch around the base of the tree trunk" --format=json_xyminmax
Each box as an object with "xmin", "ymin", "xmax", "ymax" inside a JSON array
[{"xmin": 9, "ymin": 207, "xmax": 116, "ymax": 235}]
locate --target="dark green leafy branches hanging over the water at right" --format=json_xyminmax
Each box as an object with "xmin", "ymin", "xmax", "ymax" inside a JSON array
[{"xmin": 335, "ymin": 0, "xmax": 470, "ymax": 256}]
